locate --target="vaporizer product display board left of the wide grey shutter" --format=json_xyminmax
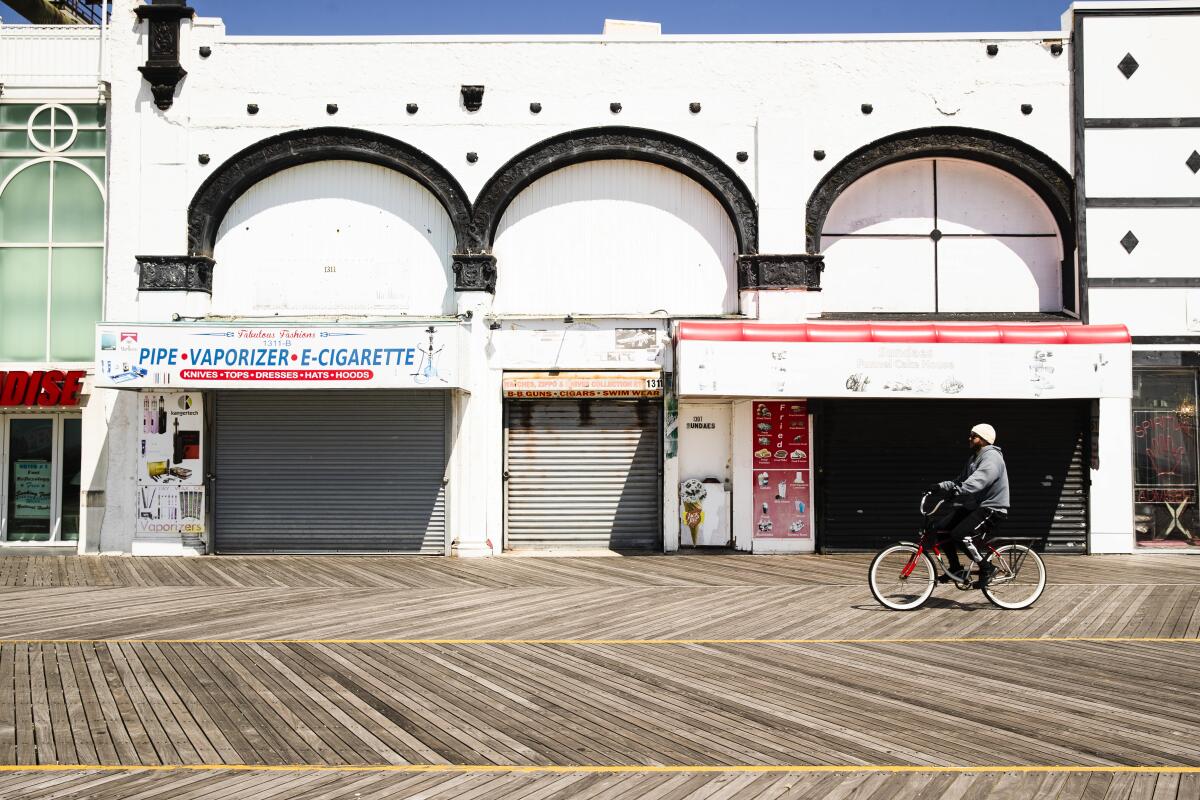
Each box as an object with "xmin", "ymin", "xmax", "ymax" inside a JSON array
[{"xmin": 137, "ymin": 391, "xmax": 204, "ymax": 536}]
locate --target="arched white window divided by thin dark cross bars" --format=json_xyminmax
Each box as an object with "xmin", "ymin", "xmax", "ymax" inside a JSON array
[{"xmin": 821, "ymin": 158, "xmax": 1063, "ymax": 314}]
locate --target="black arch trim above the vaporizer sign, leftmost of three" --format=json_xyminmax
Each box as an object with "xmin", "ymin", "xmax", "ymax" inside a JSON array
[{"xmin": 187, "ymin": 127, "xmax": 470, "ymax": 258}]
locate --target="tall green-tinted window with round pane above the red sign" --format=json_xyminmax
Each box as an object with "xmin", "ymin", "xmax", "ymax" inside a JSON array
[{"xmin": 0, "ymin": 103, "xmax": 104, "ymax": 361}]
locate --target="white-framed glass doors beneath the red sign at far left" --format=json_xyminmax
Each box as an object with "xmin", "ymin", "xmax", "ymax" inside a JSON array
[{"xmin": 0, "ymin": 414, "xmax": 82, "ymax": 545}]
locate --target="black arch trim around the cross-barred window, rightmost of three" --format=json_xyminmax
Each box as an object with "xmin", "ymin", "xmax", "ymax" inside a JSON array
[{"xmin": 804, "ymin": 127, "xmax": 1075, "ymax": 256}]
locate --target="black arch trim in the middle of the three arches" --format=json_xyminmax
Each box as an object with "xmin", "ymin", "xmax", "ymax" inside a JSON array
[{"xmin": 472, "ymin": 126, "xmax": 758, "ymax": 254}]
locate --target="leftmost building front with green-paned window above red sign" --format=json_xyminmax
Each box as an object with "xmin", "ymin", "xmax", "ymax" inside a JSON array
[{"xmin": 0, "ymin": 24, "xmax": 108, "ymax": 551}]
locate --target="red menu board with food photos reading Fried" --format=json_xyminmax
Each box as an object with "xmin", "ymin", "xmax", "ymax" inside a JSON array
[{"xmin": 751, "ymin": 399, "xmax": 812, "ymax": 539}]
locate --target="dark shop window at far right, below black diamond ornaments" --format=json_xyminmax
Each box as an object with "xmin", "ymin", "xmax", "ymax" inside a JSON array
[{"xmin": 1133, "ymin": 369, "xmax": 1200, "ymax": 547}]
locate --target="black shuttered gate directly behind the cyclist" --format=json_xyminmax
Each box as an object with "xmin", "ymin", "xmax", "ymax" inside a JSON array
[{"xmin": 815, "ymin": 401, "xmax": 1091, "ymax": 553}]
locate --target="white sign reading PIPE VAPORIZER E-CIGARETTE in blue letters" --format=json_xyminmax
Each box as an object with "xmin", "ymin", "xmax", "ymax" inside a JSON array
[{"xmin": 96, "ymin": 324, "xmax": 466, "ymax": 389}]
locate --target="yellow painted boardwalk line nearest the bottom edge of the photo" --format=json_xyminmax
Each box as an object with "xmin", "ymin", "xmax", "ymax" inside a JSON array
[{"xmin": 0, "ymin": 764, "xmax": 1200, "ymax": 775}]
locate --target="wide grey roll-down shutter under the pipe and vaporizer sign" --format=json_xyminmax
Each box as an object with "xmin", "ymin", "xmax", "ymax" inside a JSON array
[{"xmin": 214, "ymin": 390, "xmax": 449, "ymax": 554}]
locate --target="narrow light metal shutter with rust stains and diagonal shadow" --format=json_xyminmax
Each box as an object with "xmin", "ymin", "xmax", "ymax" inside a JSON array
[{"xmin": 504, "ymin": 399, "xmax": 662, "ymax": 549}]
